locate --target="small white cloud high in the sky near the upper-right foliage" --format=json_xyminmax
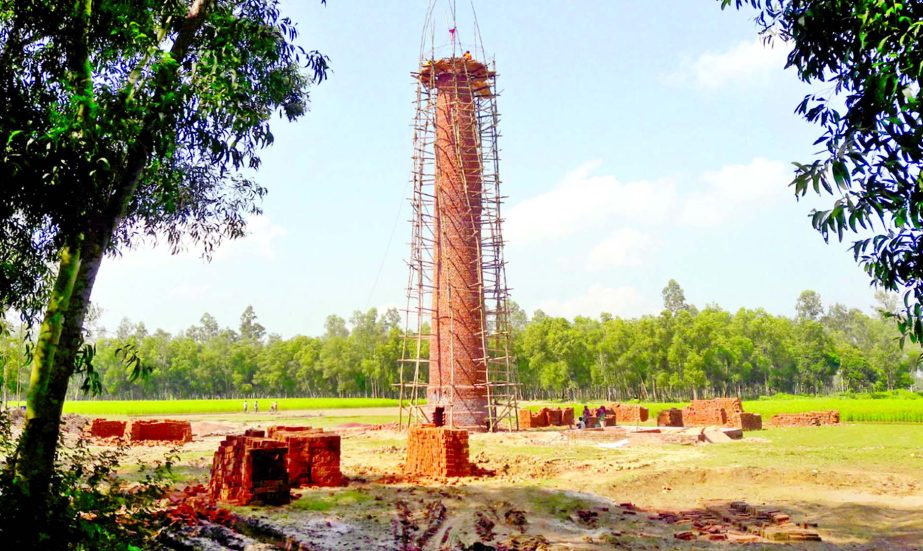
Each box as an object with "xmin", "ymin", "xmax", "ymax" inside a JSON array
[{"xmin": 663, "ymin": 38, "xmax": 788, "ymax": 90}]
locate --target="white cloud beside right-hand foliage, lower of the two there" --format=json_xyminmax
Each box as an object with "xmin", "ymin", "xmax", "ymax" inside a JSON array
[{"xmin": 679, "ymin": 158, "xmax": 792, "ymax": 228}]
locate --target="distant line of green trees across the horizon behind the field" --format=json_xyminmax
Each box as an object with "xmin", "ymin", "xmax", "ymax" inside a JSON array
[{"xmin": 0, "ymin": 280, "xmax": 920, "ymax": 400}]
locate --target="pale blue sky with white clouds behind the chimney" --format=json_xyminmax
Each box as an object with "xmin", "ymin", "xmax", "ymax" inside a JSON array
[{"xmin": 93, "ymin": 0, "xmax": 873, "ymax": 337}]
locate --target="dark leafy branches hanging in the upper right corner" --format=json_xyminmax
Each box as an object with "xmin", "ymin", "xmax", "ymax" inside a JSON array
[{"xmin": 720, "ymin": 0, "xmax": 923, "ymax": 342}]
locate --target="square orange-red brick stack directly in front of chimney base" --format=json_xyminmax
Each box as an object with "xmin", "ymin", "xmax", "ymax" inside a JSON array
[{"xmin": 405, "ymin": 424, "xmax": 472, "ymax": 478}]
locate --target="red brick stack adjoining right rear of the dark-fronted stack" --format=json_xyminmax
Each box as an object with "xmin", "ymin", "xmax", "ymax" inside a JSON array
[{"xmin": 269, "ymin": 426, "xmax": 344, "ymax": 487}]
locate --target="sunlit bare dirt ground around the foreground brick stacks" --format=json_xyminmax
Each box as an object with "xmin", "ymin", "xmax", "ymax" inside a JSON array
[{"xmin": 79, "ymin": 408, "xmax": 923, "ymax": 551}]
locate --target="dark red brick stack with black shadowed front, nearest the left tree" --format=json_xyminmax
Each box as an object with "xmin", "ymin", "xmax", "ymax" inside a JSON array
[{"xmin": 208, "ymin": 431, "xmax": 291, "ymax": 505}]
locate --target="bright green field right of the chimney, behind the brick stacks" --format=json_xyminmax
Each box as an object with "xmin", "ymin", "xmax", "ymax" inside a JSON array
[{"xmin": 527, "ymin": 392, "xmax": 923, "ymax": 423}]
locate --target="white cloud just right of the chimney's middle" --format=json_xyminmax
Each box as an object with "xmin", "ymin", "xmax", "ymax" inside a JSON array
[{"xmin": 505, "ymin": 161, "xmax": 674, "ymax": 244}]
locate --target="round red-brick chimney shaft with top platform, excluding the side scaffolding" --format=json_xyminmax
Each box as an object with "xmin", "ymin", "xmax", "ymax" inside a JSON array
[{"xmin": 419, "ymin": 55, "xmax": 491, "ymax": 430}]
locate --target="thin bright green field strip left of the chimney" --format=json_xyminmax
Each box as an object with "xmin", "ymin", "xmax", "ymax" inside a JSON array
[{"xmin": 43, "ymin": 398, "xmax": 398, "ymax": 416}]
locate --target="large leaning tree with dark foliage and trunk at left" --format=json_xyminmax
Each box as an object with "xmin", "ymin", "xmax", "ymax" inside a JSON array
[{"xmin": 0, "ymin": 0, "xmax": 326, "ymax": 532}]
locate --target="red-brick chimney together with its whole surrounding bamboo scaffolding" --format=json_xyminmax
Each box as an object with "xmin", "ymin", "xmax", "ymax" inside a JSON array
[{"xmin": 398, "ymin": 44, "xmax": 518, "ymax": 431}]
